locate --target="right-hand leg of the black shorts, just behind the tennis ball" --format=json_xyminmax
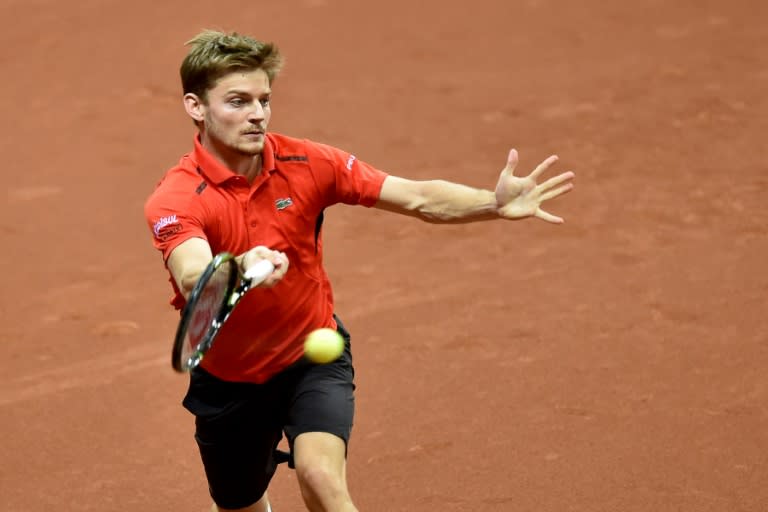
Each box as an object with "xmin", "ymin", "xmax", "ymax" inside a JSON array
[{"xmin": 285, "ymin": 323, "xmax": 355, "ymax": 447}]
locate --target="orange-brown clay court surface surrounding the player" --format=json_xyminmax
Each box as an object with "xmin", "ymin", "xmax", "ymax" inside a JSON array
[{"xmin": 0, "ymin": 0, "xmax": 768, "ymax": 512}]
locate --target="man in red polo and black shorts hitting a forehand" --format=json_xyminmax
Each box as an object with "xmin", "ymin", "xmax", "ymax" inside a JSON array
[{"xmin": 145, "ymin": 31, "xmax": 574, "ymax": 512}]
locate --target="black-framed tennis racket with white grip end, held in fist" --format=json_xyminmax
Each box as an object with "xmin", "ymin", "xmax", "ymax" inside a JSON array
[{"xmin": 171, "ymin": 252, "xmax": 275, "ymax": 372}]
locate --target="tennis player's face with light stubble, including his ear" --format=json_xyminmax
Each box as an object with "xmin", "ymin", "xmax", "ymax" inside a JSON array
[{"xmin": 184, "ymin": 69, "xmax": 272, "ymax": 159}]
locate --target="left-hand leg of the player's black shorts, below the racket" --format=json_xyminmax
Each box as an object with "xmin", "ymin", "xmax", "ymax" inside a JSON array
[{"xmin": 184, "ymin": 369, "xmax": 282, "ymax": 509}]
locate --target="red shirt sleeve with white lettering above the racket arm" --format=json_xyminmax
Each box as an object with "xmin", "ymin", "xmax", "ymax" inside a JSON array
[{"xmin": 144, "ymin": 174, "xmax": 207, "ymax": 261}]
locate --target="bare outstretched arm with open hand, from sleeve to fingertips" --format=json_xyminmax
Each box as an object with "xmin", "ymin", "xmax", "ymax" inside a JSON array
[{"xmin": 375, "ymin": 149, "xmax": 574, "ymax": 224}]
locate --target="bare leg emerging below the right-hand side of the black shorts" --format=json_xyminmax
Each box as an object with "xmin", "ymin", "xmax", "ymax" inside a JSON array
[{"xmin": 293, "ymin": 432, "xmax": 357, "ymax": 512}]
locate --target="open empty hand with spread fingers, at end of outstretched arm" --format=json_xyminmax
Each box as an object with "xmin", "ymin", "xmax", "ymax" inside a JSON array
[{"xmin": 496, "ymin": 149, "xmax": 575, "ymax": 224}]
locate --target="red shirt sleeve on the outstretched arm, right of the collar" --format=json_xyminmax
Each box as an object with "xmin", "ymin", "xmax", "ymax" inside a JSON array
[{"xmin": 311, "ymin": 143, "xmax": 388, "ymax": 207}]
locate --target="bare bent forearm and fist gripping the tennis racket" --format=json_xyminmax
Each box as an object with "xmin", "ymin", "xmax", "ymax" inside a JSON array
[{"xmin": 167, "ymin": 238, "xmax": 288, "ymax": 299}]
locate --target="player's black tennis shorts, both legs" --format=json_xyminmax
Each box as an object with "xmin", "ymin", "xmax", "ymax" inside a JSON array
[{"xmin": 183, "ymin": 319, "xmax": 355, "ymax": 508}]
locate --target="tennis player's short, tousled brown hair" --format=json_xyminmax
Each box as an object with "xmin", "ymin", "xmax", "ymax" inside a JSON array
[{"xmin": 179, "ymin": 30, "xmax": 283, "ymax": 102}]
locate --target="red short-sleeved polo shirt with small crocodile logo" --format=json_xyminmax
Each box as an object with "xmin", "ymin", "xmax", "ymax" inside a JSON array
[{"xmin": 145, "ymin": 133, "xmax": 387, "ymax": 383}]
